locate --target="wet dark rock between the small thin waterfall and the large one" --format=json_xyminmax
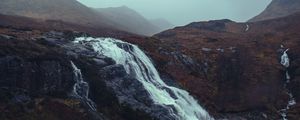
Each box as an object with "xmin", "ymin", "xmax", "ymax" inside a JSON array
[{"xmin": 101, "ymin": 65, "xmax": 173, "ymax": 120}]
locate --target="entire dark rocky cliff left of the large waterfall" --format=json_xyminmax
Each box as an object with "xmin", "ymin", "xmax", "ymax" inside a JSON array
[{"xmin": 0, "ymin": 27, "xmax": 176, "ymax": 120}]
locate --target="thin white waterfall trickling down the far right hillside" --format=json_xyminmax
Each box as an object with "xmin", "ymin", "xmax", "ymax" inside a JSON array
[{"xmin": 280, "ymin": 49, "xmax": 296, "ymax": 120}]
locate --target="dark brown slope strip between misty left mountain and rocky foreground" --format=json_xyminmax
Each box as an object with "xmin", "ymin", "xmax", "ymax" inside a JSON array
[{"xmin": 0, "ymin": 14, "xmax": 136, "ymax": 39}]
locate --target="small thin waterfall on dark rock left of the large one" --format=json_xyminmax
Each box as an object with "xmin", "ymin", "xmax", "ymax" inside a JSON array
[{"xmin": 71, "ymin": 61, "xmax": 97, "ymax": 111}]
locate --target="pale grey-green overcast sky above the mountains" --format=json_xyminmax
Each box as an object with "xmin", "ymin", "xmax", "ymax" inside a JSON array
[{"xmin": 78, "ymin": 0, "xmax": 271, "ymax": 25}]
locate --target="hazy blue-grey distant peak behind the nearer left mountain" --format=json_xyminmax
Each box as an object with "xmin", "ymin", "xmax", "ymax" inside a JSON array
[{"xmin": 96, "ymin": 6, "xmax": 160, "ymax": 35}]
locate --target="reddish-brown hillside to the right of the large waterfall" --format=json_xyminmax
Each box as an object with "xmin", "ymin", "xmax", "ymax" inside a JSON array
[{"xmin": 154, "ymin": 14, "xmax": 300, "ymax": 120}]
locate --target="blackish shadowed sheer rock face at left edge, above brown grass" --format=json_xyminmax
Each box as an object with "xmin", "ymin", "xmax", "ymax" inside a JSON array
[{"xmin": 0, "ymin": 56, "xmax": 74, "ymax": 96}]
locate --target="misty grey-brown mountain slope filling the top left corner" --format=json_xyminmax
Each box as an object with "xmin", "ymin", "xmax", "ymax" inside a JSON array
[{"xmin": 0, "ymin": 0, "xmax": 116, "ymax": 28}]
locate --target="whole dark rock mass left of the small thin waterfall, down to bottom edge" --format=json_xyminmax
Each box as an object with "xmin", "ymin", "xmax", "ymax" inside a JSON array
[{"xmin": 0, "ymin": 35, "xmax": 109, "ymax": 120}]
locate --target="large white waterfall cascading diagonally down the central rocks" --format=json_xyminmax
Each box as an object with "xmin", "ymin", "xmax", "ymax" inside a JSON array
[{"xmin": 74, "ymin": 37, "xmax": 214, "ymax": 120}]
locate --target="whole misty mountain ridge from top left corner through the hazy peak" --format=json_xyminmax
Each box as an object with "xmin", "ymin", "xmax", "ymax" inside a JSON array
[{"xmin": 0, "ymin": 0, "xmax": 166, "ymax": 36}]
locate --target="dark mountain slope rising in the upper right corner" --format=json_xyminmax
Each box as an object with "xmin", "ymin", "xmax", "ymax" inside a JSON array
[{"xmin": 249, "ymin": 0, "xmax": 300, "ymax": 22}]
